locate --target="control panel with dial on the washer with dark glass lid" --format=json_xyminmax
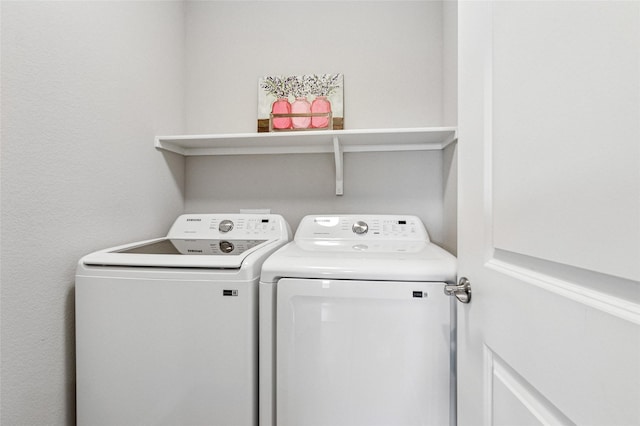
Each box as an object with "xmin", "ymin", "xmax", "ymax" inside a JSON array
[{"xmin": 167, "ymin": 214, "xmax": 289, "ymax": 240}]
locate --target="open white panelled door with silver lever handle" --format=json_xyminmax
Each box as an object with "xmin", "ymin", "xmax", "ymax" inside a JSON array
[{"xmin": 458, "ymin": 1, "xmax": 640, "ymax": 425}]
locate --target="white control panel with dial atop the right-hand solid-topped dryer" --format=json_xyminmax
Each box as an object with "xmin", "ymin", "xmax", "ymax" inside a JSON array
[{"xmin": 295, "ymin": 215, "xmax": 429, "ymax": 242}]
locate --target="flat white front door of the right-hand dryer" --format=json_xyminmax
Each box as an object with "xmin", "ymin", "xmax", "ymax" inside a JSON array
[{"xmin": 276, "ymin": 279, "xmax": 451, "ymax": 426}]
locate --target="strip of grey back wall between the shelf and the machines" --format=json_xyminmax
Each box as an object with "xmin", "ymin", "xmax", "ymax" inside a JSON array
[{"xmin": 185, "ymin": 152, "xmax": 443, "ymax": 241}]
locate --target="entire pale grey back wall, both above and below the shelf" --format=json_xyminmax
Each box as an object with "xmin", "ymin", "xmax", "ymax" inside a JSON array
[{"xmin": 185, "ymin": 1, "xmax": 444, "ymax": 241}]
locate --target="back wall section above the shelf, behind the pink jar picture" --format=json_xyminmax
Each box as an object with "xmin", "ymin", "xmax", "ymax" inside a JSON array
[{"xmin": 186, "ymin": 1, "xmax": 443, "ymax": 133}]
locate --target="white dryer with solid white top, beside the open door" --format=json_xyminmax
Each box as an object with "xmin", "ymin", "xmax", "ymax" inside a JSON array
[{"xmin": 260, "ymin": 215, "xmax": 456, "ymax": 426}]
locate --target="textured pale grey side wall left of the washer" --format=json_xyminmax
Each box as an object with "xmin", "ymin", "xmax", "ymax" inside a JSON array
[{"xmin": 0, "ymin": 1, "xmax": 184, "ymax": 425}]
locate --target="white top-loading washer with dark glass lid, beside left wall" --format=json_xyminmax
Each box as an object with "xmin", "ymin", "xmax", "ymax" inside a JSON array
[{"xmin": 75, "ymin": 214, "xmax": 291, "ymax": 426}]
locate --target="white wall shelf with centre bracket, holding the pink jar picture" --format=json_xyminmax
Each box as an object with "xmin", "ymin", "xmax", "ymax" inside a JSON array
[{"xmin": 155, "ymin": 127, "xmax": 457, "ymax": 195}]
